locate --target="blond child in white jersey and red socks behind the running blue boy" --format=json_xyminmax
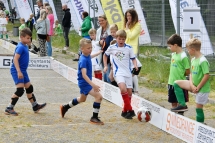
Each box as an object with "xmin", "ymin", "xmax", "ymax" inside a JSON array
[{"xmin": 88, "ymin": 28, "xmax": 102, "ymax": 80}]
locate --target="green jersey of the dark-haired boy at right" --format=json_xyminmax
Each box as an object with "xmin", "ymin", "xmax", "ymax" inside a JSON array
[{"xmin": 168, "ymin": 52, "xmax": 190, "ymax": 85}]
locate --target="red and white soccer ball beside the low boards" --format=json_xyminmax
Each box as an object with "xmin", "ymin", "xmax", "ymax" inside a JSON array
[{"xmin": 137, "ymin": 107, "xmax": 152, "ymax": 122}]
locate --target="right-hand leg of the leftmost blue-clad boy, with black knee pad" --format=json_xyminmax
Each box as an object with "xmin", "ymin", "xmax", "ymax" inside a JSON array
[{"xmin": 25, "ymin": 82, "xmax": 46, "ymax": 113}]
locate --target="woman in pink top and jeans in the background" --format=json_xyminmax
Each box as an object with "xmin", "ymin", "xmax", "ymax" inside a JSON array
[{"xmin": 46, "ymin": 6, "xmax": 54, "ymax": 56}]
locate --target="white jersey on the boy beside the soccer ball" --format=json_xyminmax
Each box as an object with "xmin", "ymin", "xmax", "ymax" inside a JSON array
[{"xmin": 105, "ymin": 44, "xmax": 135, "ymax": 77}]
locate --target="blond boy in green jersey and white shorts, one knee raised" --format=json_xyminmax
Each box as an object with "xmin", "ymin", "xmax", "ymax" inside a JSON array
[{"xmin": 172, "ymin": 38, "xmax": 210, "ymax": 123}]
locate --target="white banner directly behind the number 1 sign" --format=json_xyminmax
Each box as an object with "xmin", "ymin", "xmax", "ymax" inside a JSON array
[{"xmin": 169, "ymin": 0, "xmax": 213, "ymax": 55}]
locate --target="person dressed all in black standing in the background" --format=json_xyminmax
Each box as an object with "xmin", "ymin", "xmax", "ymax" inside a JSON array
[{"xmin": 62, "ymin": 5, "xmax": 71, "ymax": 50}]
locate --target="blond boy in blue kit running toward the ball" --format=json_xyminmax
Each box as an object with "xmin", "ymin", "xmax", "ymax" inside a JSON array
[{"xmin": 60, "ymin": 38, "xmax": 104, "ymax": 125}]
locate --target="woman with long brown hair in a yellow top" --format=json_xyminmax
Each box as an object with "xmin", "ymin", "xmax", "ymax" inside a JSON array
[{"xmin": 124, "ymin": 9, "xmax": 141, "ymax": 55}]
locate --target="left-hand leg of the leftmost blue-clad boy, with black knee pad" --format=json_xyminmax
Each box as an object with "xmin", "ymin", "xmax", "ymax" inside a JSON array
[{"xmin": 5, "ymin": 83, "xmax": 25, "ymax": 116}]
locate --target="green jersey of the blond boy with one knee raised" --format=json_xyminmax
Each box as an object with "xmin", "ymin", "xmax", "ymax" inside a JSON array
[{"xmin": 191, "ymin": 56, "xmax": 210, "ymax": 93}]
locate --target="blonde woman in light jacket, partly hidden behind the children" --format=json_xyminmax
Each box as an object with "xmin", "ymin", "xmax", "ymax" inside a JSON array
[{"xmin": 96, "ymin": 15, "xmax": 111, "ymax": 83}]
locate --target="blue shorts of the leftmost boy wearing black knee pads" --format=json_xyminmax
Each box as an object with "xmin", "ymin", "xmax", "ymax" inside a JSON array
[{"xmin": 11, "ymin": 71, "xmax": 30, "ymax": 85}]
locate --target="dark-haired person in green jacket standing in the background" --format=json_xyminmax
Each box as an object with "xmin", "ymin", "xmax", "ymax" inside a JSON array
[{"xmin": 80, "ymin": 11, "xmax": 92, "ymax": 39}]
